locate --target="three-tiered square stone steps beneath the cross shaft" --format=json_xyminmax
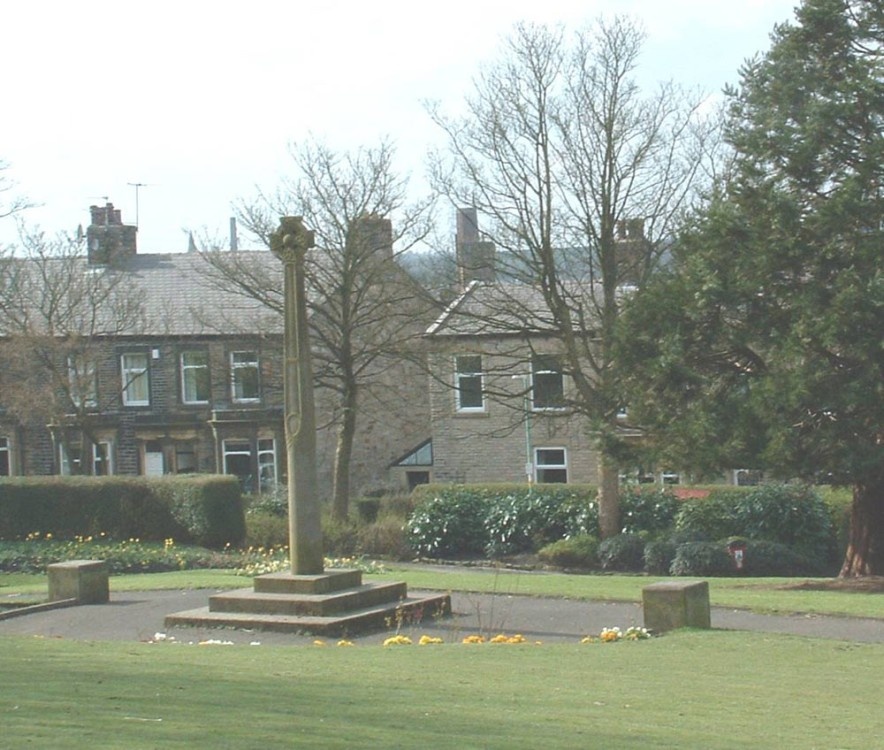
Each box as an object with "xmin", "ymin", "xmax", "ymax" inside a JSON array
[{"xmin": 165, "ymin": 570, "xmax": 451, "ymax": 636}]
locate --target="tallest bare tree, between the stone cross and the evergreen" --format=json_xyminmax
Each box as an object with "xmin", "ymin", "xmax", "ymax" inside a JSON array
[{"xmin": 430, "ymin": 17, "xmax": 715, "ymax": 536}]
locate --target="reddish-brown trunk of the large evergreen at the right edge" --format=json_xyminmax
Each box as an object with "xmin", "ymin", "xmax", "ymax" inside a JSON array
[{"xmin": 840, "ymin": 477, "xmax": 884, "ymax": 578}]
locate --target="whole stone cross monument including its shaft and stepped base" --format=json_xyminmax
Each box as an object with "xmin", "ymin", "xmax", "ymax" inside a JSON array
[{"xmin": 165, "ymin": 216, "xmax": 451, "ymax": 635}]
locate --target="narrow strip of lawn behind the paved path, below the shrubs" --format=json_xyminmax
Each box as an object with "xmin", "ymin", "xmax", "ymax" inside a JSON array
[{"xmin": 0, "ymin": 566, "xmax": 884, "ymax": 619}]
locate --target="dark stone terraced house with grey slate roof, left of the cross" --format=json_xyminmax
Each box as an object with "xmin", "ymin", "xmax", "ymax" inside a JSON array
[{"xmin": 0, "ymin": 203, "xmax": 431, "ymax": 500}]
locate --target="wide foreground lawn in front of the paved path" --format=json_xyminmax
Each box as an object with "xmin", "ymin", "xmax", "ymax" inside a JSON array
[{"xmin": 0, "ymin": 631, "xmax": 884, "ymax": 750}]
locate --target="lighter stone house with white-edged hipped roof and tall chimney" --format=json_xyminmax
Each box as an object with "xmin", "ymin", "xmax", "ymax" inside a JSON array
[{"xmin": 403, "ymin": 209, "xmax": 598, "ymax": 483}]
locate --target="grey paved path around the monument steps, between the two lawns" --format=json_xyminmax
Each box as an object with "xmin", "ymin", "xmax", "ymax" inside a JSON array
[{"xmin": 0, "ymin": 590, "xmax": 884, "ymax": 645}]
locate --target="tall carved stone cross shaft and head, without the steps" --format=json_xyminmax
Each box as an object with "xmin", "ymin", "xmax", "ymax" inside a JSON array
[{"xmin": 270, "ymin": 216, "xmax": 323, "ymax": 575}]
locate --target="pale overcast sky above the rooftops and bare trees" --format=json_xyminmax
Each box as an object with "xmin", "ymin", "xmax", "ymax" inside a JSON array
[{"xmin": 0, "ymin": 0, "xmax": 797, "ymax": 253}]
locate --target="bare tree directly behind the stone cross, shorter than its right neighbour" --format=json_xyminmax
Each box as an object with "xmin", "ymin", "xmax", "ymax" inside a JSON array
[{"xmin": 205, "ymin": 140, "xmax": 432, "ymax": 519}]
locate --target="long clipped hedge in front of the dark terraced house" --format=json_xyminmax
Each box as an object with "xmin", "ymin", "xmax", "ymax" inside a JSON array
[{"xmin": 0, "ymin": 474, "xmax": 245, "ymax": 548}]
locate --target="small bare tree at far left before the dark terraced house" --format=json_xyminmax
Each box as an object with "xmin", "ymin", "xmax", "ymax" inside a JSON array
[{"xmin": 0, "ymin": 231, "xmax": 144, "ymax": 470}]
